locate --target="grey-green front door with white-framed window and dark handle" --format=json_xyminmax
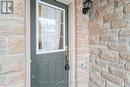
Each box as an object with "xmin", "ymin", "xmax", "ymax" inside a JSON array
[{"xmin": 30, "ymin": 0, "xmax": 69, "ymax": 87}]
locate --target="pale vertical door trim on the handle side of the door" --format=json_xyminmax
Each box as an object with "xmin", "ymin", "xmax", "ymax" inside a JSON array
[{"xmin": 68, "ymin": 0, "xmax": 76, "ymax": 87}]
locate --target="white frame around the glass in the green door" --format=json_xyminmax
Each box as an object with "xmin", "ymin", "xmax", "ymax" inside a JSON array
[{"xmin": 36, "ymin": 0, "xmax": 66, "ymax": 55}]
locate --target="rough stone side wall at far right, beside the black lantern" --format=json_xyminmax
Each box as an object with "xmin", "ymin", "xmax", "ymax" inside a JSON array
[{"xmin": 89, "ymin": 0, "xmax": 130, "ymax": 87}]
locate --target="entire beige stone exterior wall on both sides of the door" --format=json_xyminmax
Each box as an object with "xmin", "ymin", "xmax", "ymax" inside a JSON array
[{"xmin": 0, "ymin": 0, "xmax": 130, "ymax": 87}]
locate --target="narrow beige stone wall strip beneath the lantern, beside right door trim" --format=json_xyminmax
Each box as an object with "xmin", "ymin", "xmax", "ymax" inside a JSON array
[{"xmin": 75, "ymin": 0, "xmax": 89, "ymax": 87}]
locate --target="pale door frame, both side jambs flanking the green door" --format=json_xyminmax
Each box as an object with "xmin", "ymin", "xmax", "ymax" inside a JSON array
[{"xmin": 25, "ymin": 0, "xmax": 76, "ymax": 87}]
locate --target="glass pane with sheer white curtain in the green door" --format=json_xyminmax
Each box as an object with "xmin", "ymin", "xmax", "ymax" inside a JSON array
[{"xmin": 37, "ymin": 4, "xmax": 65, "ymax": 52}]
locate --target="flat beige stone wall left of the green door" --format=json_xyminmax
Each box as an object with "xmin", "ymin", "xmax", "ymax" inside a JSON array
[{"xmin": 0, "ymin": 0, "xmax": 26, "ymax": 87}]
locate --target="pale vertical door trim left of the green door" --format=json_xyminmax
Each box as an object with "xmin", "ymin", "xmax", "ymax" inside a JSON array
[{"xmin": 25, "ymin": 0, "xmax": 31, "ymax": 87}]
